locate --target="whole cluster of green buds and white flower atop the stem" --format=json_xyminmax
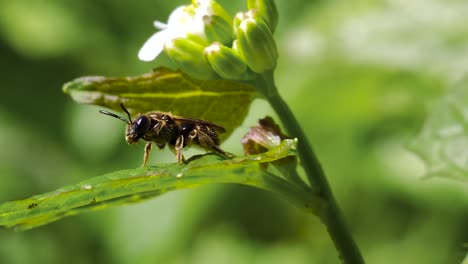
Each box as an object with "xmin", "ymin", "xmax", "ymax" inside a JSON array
[{"xmin": 138, "ymin": 0, "xmax": 278, "ymax": 80}]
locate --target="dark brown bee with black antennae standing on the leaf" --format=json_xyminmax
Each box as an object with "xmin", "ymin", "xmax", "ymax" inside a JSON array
[{"xmin": 99, "ymin": 103, "xmax": 232, "ymax": 166}]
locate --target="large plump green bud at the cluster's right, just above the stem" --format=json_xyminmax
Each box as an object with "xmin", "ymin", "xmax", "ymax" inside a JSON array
[{"xmin": 237, "ymin": 18, "xmax": 278, "ymax": 73}]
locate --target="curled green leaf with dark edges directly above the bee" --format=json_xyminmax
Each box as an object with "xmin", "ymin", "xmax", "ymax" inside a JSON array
[{"xmin": 63, "ymin": 67, "xmax": 255, "ymax": 136}]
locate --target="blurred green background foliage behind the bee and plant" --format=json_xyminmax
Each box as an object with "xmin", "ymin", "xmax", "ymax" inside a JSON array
[{"xmin": 0, "ymin": 0, "xmax": 468, "ymax": 264}]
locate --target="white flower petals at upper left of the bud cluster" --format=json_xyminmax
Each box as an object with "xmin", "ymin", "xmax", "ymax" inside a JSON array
[{"xmin": 138, "ymin": 0, "xmax": 218, "ymax": 61}]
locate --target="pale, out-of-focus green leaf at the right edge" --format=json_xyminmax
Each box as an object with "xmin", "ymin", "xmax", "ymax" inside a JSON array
[{"xmin": 409, "ymin": 85, "xmax": 468, "ymax": 183}]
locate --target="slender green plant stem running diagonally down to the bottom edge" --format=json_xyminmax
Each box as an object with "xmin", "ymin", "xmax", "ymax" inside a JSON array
[{"xmin": 256, "ymin": 71, "xmax": 364, "ymax": 263}]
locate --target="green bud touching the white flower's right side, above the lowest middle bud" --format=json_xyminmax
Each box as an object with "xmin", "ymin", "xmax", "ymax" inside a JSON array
[{"xmin": 203, "ymin": 15, "xmax": 234, "ymax": 44}]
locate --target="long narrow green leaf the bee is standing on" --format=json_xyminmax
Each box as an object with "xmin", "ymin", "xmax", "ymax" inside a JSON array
[{"xmin": 0, "ymin": 140, "xmax": 321, "ymax": 230}]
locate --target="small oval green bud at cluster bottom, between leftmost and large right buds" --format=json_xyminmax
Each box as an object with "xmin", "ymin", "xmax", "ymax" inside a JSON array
[{"xmin": 204, "ymin": 42, "xmax": 247, "ymax": 80}]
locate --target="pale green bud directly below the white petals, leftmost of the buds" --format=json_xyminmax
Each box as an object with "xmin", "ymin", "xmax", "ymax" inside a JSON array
[{"xmin": 164, "ymin": 38, "xmax": 217, "ymax": 79}]
